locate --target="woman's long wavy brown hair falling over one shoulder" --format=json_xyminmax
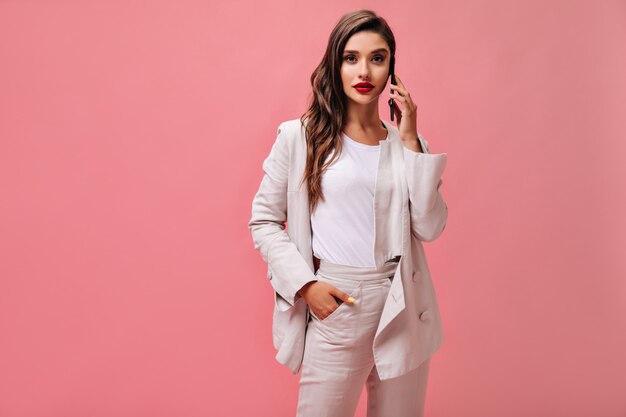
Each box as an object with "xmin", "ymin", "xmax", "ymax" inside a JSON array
[{"xmin": 300, "ymin": 9, "xmax": 396, "ymax": 213}]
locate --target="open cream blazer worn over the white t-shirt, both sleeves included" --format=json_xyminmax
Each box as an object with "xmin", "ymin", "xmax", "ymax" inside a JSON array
[{"xmin": 248, "ymin": 119, "xmax": 448, "ymax": 380}]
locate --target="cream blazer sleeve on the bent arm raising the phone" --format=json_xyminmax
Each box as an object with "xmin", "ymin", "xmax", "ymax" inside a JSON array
[{"xmin": 404, "ymin": 132, "xmax": 448, "ymax": 242}]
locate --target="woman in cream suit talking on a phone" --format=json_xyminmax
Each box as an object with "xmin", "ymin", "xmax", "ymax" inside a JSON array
[{"xmin": 248, "ymin": 10, "xmax": 448, "ymax": 417}]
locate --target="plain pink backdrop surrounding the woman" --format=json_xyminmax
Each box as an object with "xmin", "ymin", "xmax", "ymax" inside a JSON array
[{"xmin": 0, "ymin": 0, "xmax": 626, "ymax": 417}]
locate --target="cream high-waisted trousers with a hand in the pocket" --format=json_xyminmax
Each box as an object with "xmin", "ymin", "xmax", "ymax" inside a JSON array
[{"xmin": 296, "ymin": 259, "xmax": 430, "ymax": 417}]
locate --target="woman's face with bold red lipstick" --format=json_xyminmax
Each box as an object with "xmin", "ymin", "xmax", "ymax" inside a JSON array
[{"xmin": 341, "ymin": 31, "xmax": 390, "ymax": 104}]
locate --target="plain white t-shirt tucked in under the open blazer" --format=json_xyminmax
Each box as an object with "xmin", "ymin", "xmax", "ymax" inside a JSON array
[{"xmin": 311, "ymin": 133, "xmax": 389, "ymax": 267}]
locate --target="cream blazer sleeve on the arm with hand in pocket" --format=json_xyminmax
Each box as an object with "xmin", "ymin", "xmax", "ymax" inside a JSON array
[{"xmin": 248, "ymin": 122, "xmax": 317, "ymax": 311}]
